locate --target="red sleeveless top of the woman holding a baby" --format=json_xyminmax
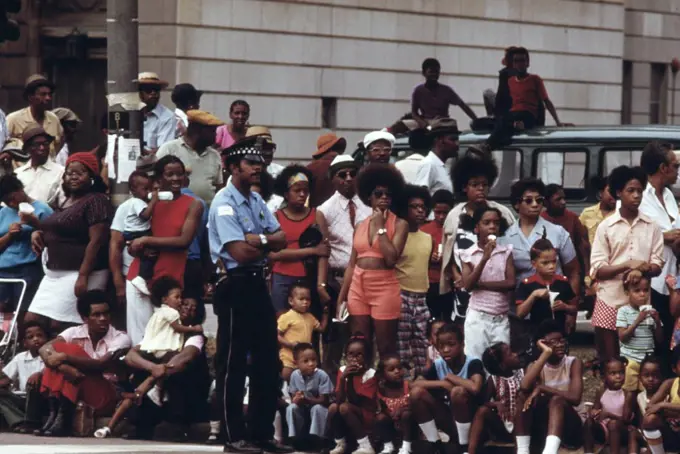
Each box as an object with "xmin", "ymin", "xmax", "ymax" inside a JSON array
[{"xmin": 128, "ymin": 194, "xmax": 195, "ymax": 286}]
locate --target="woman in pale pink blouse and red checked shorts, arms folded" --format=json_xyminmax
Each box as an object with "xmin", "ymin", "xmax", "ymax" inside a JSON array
[{"xmin": 590, "ymin": 166, "xmax": 664, "ymax": 364}]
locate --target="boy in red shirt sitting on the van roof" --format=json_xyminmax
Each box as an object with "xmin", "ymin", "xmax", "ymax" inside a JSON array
[{"xmin": 487, "ymin": 47, "xmax": 563, "ymax": 150}]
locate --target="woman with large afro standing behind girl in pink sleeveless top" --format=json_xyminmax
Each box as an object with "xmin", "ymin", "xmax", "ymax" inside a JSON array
[{"xmin": 438, "ymin": 152, "xmax": 515, "ymax": 320}]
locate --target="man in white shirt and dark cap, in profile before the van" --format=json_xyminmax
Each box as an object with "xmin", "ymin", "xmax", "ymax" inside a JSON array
[{"xmin": 413, "ymin": 118, "xmax": 460, "ymax": 194}]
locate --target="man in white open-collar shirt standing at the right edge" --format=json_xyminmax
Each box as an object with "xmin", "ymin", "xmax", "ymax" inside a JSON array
[{"xmin": 640, "ymin": 141, "xmax": 680, "ymax": 352}]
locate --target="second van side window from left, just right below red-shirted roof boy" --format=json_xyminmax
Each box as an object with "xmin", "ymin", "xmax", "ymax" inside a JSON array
[{"xmin": 533, "ymin": 148, "xmax": 588, "ymax": 189}]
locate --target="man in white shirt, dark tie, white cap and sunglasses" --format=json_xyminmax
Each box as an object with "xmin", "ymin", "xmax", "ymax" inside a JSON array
[{"xmin": 317, "ymin": 155, "xmax": 372, "ymax": 376}]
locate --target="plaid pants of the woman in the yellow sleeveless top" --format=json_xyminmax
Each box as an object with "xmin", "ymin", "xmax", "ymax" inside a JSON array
[{"xmin": 397, "ymin": 290, "xmax": 430, "ymax": 378}]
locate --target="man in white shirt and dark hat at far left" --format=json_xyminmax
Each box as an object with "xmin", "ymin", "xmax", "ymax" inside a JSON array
[{"xmin": 15, "ymin": 126, "xmax": 64, "ymax": 203}]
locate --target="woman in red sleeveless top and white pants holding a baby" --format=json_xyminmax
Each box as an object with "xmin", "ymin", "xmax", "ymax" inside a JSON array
[{"xmin": 126, "ymin": 155, "xmax": 203, "ymax": 343}]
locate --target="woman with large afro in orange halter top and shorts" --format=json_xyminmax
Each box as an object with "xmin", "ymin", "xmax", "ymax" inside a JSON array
[{"xmin": 338, "ymin": 164, "xmax": 408, "ymax": 357}]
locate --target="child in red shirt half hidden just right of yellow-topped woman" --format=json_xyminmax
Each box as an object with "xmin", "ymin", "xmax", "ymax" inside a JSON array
[{"xmin": 420, "ymin": 189, "xmax": 454, "ymax": 320}]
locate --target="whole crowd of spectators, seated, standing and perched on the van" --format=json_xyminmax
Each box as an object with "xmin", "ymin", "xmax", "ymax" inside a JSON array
[{"xmin": 0, "ymin": 48, "xmax": 680, "ymax": 454}]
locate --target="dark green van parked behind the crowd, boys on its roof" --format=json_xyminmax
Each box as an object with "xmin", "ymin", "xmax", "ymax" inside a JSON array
[{"xmin": 355, "ymin": 125, "xmax": 680, "ymax": 212}]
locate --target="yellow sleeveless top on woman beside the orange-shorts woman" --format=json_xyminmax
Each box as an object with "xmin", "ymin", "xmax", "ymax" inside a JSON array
[{"xmin": 396, "ymin": 230, "xmax": 432, "ymax": 293}]
